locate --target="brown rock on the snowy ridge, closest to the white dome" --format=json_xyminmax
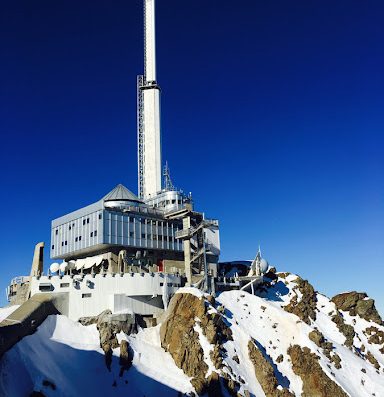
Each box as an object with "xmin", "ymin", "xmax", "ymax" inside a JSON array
[{"xmin": 284, "ymin": 277, "xmax": 317, "ymax": 324}]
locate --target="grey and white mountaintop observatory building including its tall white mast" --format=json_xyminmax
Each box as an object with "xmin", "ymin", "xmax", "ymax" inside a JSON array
[{"xmin": 7, "ymin": 0, "xmax": 220, "ymax": 320}]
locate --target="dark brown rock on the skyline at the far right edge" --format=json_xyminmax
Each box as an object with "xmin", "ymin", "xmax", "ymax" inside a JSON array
[{"xmin": 331, "ymin": 291, "xmax": 384, "ymax": 325}]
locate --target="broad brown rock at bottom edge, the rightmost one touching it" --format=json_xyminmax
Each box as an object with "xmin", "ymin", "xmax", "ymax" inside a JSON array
[{"xmin": 288, "ymin": 345, "xmax": 348, "ymax": 397}]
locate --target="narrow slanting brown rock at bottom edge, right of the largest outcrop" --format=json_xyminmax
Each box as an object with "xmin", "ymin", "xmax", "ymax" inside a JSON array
[{"xmin": 248, "ymin": 341, "xmax": 294, "ymax": 397}]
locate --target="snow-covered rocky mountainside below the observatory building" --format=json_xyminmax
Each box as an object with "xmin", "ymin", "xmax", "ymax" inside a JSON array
[{"xmin": 0, "ymin": 274, "xmax": 384, "ymax": 397}]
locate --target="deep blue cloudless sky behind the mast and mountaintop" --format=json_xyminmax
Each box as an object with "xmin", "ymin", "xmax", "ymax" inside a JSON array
[{"xmin": 0, "ymin": 0, "xmax": 384, "ymax": 313}]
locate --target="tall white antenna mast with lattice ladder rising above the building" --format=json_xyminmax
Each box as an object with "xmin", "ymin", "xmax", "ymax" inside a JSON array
[{"xmin": 137, "ymin": 0, "xmax": 161, "ymax": 199}]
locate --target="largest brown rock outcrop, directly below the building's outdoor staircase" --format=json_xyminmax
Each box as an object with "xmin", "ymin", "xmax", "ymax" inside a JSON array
[{"xmin": 160, "ymin": 293, "xmax": 232, "ymax": 395}]
